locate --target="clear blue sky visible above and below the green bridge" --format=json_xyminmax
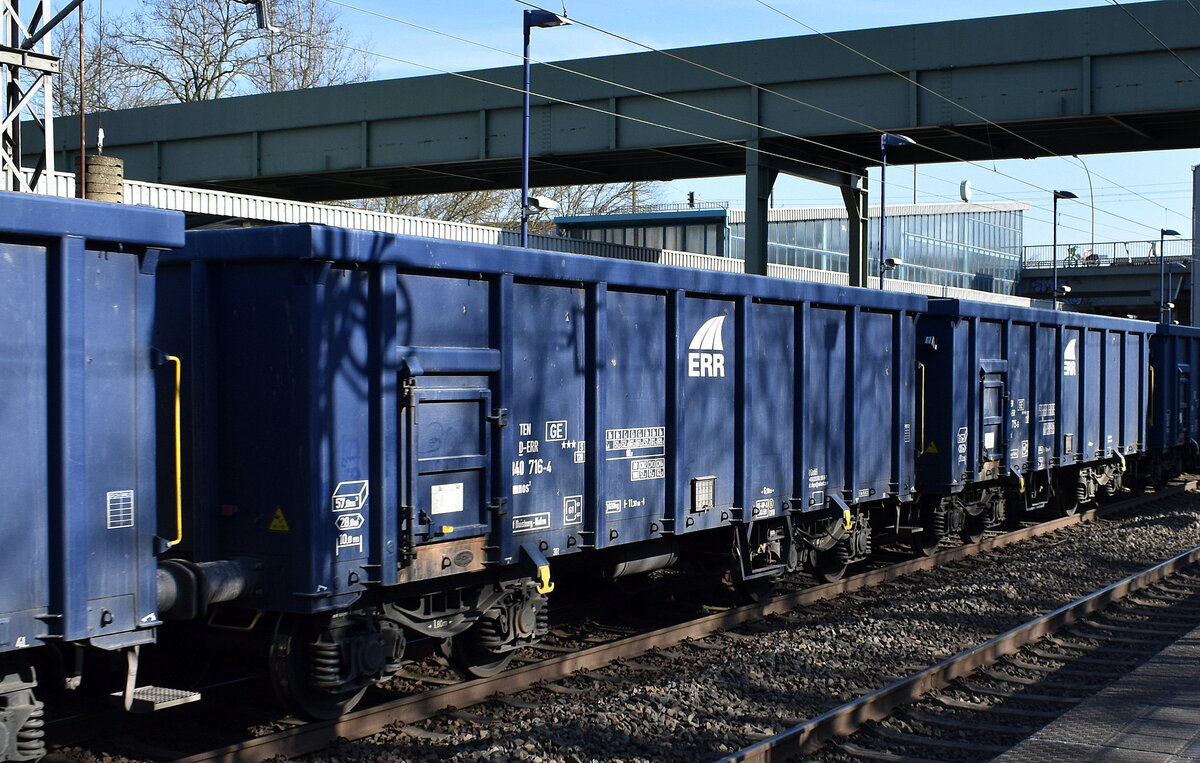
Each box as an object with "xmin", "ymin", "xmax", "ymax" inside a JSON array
[{"xmin": 108, "ymin": 0, "xmax": 1200, "ymax": 244}]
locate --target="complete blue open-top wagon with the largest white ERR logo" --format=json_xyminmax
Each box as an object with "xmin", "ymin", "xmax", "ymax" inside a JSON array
[{"xmin": 156, "ymin": 226, "xmax": 925, "ymax": 715}]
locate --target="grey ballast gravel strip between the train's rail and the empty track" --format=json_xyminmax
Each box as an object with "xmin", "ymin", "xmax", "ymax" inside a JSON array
[{"xmin": 306, "ymin": 495, "xmax": 1200, "ymax": 763}]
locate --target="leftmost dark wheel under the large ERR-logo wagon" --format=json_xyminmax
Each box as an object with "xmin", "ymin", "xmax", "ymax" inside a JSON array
[{"xmin": 268, "ymin": 614, "xmax": 366, "ymax": 721}]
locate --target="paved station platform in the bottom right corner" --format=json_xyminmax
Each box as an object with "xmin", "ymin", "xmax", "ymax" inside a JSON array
[{"xmin": 995, "ymin": 627, "xmax": 1200, "ymax": 763}]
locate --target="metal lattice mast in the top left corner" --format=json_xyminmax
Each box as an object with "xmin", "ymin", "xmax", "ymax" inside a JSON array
[{"xmin": 0, "ymin": 0, "xmax": 72, "ymax": 192}]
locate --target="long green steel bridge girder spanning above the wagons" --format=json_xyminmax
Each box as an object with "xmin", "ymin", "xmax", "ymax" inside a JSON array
[{"xmin": 29, "ymin": 1, "xmax": 1200, "ymax": 200}]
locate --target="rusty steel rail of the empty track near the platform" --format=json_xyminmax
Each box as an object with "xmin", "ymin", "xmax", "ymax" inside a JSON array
[{"xmin": 720, "ymin": 506, "xmax": 1200, "ymax": 763}]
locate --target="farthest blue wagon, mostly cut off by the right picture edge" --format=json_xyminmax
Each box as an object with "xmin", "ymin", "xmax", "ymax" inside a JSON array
[{"xmin": 1142, "ymin": 324, "xmax": 1200, "ymax": 483}]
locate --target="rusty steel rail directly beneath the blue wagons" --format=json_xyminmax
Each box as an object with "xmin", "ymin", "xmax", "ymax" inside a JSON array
[{"xmin": 178, "ymin": 481, "xmax": 1200, "ymax": 763}]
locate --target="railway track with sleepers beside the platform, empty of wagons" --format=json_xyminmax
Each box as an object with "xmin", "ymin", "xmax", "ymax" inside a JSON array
[{"xmin": 724, "ymin": 539, "xmax": 1200, "ymax": 763}]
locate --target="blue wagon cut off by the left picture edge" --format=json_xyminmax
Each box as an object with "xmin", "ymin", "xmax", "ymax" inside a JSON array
[{"xmin": 0, "ymin": 193, "xmax": 184, "ymax": 761}]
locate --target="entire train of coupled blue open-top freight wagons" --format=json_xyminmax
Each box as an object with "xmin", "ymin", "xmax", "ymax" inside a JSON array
[{"xmin": 0, "ymin": 194, "xmax": 1180, "ymax": 761}]
